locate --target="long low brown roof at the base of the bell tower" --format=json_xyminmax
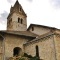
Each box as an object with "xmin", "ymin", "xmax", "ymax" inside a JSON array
[{"xmin": 0, "ymin": 30, "xmax": 38, "ymax": 37}]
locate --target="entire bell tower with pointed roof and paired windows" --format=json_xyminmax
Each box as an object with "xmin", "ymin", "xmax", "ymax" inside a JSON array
[{"xmin": 7, "ymin": 0, "xmax": 27, "ymax": 31}]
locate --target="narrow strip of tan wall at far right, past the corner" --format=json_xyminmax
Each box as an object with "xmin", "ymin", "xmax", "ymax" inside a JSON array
[{"xmin": 54, "ymin": 34, "xmax": 60, "ymax": 60}]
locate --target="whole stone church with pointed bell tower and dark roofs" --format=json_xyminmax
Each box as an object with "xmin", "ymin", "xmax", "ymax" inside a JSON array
[{"xmin": 0, "ymin": 0, "xmax": 60, "ymax": 60}]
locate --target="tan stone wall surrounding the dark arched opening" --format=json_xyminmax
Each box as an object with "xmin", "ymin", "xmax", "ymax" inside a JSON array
[{"xmin": 5, "ymin": 34, "xmax": 28, "ymax": 59}]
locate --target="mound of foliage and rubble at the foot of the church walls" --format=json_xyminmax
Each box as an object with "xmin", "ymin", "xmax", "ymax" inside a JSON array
[{"xmin": 9, "ymin": 53, "xmax": 41, "ymax": 60}]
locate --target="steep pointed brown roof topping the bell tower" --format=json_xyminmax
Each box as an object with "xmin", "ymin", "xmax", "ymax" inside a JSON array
[{"xmin": 7, "ymin": 0, "xmax": 27, "ymax": 19}]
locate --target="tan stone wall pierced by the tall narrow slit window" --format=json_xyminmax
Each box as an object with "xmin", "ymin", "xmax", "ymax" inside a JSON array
[{"xmin": 25, "ymin": 35, "xmax": 55, "ymax": 60}]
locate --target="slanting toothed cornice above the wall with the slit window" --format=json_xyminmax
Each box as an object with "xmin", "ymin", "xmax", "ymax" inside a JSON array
[{"xmin": 24, "ymin": 33, "xmax": 55, "ymax": 46}]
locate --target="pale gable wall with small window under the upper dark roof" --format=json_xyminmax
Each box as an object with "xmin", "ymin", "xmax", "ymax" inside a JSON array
[{"xmin": 29, "ymin": 26, "xmax": 50, "ymax": 35}]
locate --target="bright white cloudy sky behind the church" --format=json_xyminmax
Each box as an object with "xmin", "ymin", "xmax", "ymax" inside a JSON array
[{"xmin": 0, "ymin": 0, "xmax": 60, "ymax": 30}]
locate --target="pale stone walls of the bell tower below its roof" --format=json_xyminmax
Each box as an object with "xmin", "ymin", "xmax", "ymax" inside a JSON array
[{"xmin": 7, "ymin": 13, "xmax": 27, "ymax": 31}]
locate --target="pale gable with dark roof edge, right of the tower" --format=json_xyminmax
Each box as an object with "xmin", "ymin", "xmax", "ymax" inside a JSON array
[{"xmin": 27, "ymin": 24, "xmax": 56, "ymax": 35}]
